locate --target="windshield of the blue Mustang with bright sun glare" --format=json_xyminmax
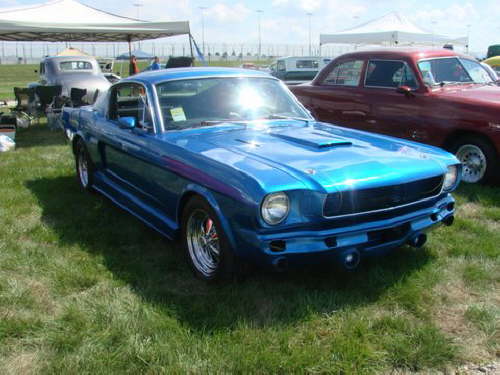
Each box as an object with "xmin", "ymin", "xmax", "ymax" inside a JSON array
[{"xmin": 156, "ymin": 77, "xmax": 311, "ymax": 130}]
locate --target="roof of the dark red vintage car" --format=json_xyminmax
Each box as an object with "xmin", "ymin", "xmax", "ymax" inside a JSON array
[{"xmin": 339, "ymin": 47, "xmax": 466, "ymax": 60}]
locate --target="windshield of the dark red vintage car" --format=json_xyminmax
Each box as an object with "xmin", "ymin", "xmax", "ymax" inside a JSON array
[{"xmin": 418, "ymin": 57, "xmax": 493, "ymax": 86}]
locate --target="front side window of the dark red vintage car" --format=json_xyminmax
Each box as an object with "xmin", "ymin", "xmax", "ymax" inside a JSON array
[{"xmin": 365, "ymin": 60, "xmax": 417, "ymax": 88}]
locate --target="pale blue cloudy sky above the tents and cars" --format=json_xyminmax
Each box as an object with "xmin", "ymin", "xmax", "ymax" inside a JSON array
[{"xmin": 0, "ymin": 0, "xmax": 500, "ymax": 54}]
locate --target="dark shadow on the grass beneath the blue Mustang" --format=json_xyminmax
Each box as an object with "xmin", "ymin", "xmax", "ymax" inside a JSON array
[{"xmin": 26, "ymin": 176, "xmax": 433, "ymax": 332}]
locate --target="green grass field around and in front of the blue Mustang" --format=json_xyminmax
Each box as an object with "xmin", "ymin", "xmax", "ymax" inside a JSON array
[{"xmin": 0, "ymin": 67, "xmax": 500, "ymax": 374}]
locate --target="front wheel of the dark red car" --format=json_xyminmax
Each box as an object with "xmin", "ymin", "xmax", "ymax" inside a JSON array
[{"xmin": 450, "ymin": 135, "xmax": 497, "ymax": 183}]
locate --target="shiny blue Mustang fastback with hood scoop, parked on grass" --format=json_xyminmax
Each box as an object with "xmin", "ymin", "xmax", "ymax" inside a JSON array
[{"xmin": 63, "ymin": 68, "xmax": 461, "ymax": 280}]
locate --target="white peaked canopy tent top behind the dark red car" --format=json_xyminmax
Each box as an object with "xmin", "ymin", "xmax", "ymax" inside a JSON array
[{"xmin": 320, "ymin": 12, "xmax": 468, "ymax": 46}]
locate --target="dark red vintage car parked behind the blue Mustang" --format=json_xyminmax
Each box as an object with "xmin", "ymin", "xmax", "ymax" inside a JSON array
[{"xmin": 291, "ymin": 48, "xmax": 500, "ymax": 183}]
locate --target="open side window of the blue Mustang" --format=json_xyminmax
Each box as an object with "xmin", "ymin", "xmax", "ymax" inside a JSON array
[{"xmin": 109, "ymin": 83, "xmax": 153, "ymax": 130}]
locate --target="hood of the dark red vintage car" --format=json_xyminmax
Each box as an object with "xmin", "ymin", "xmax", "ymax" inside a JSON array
[{"xmin": 434, "ymin": 84, "xmax": 500, "ymax": 104}]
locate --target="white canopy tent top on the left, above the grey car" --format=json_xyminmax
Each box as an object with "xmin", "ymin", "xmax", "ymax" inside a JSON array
[{"xmin": 0, "ymin": 0, "xmax": 191, "ymax": 50}]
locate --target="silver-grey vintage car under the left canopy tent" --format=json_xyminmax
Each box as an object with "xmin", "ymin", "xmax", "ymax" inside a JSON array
[{"xmin": 30, "ymin": 56, "xmax": 111, "ymax": 102}]
